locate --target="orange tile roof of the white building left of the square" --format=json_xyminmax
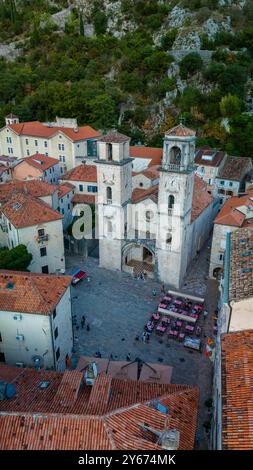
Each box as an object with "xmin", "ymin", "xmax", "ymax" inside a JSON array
[{"xmin": 0, "ymin": 269, "xmax": 72, "ymax": 314}]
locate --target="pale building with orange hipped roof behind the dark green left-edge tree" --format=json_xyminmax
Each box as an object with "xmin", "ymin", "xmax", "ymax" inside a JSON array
[{"xmin": 0, "ymin": 193, "xmax": 65, "ymax": 273}]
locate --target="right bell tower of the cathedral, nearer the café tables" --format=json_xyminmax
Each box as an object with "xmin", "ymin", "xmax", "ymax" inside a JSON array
[{"xmin": 156, "ymin": 124, "xmax": 196, "ymax": 288}]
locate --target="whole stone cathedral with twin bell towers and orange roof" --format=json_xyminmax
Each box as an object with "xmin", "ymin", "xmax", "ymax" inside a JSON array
[{"xmin": 96, "ymin": 124, "xmax": 214, "ymax": 287}]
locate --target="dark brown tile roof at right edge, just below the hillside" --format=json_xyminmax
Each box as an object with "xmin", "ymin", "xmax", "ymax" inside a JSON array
[{"xmin": 218, "ymin": 157, "xmax": 252, "ymax": 181}]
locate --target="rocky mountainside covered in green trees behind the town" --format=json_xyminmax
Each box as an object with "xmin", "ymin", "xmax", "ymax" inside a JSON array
[{"xmin": 0, "ymin": 0, "xmax": 253, "ymax": 156}]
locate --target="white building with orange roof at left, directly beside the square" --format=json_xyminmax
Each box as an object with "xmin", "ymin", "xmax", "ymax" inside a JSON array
[{"xmin": 0, "ymin": 270, "xmax": 73, "ymax": 371}]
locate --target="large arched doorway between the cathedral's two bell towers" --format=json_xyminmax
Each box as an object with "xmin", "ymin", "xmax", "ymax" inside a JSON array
[{"xmin": 122, "ymin": 242, "xmax": 155, "ymax": 279}]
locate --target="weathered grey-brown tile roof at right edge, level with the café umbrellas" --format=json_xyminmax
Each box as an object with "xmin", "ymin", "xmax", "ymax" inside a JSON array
[{"xmin": 229, "ymin": 227, "xmax": 253, "ymax": 302}]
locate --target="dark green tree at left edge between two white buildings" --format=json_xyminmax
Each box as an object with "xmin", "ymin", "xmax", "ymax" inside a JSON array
[{"xmin": 0, "ymin": 245, "xmax": 32, "ymax": 271}]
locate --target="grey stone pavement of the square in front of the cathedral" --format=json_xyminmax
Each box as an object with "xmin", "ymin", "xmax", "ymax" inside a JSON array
[{"xmin": 67, "ymin": 241, "xmax": 217, "ymax": 449}]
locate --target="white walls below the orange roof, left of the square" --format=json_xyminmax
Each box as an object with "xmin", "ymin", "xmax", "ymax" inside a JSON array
[{"xmin": 0, "ymin": 287, "xmax": 73, "ymax": 370}]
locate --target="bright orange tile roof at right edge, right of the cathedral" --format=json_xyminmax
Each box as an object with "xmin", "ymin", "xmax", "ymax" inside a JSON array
[{"xmin": 214, "ymin": 188, "xmax": 253, "ymax": 227}]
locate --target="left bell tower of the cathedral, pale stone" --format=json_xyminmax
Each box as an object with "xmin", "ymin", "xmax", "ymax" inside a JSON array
[{"xmin": 96, "ymin": 131, "xmax": 132, "ymax": 270}]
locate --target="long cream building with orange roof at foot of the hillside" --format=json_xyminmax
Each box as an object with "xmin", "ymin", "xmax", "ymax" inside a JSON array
[{"xmin": 0, "ymin": 116, "xmax": 100, "ymax": 173}]
